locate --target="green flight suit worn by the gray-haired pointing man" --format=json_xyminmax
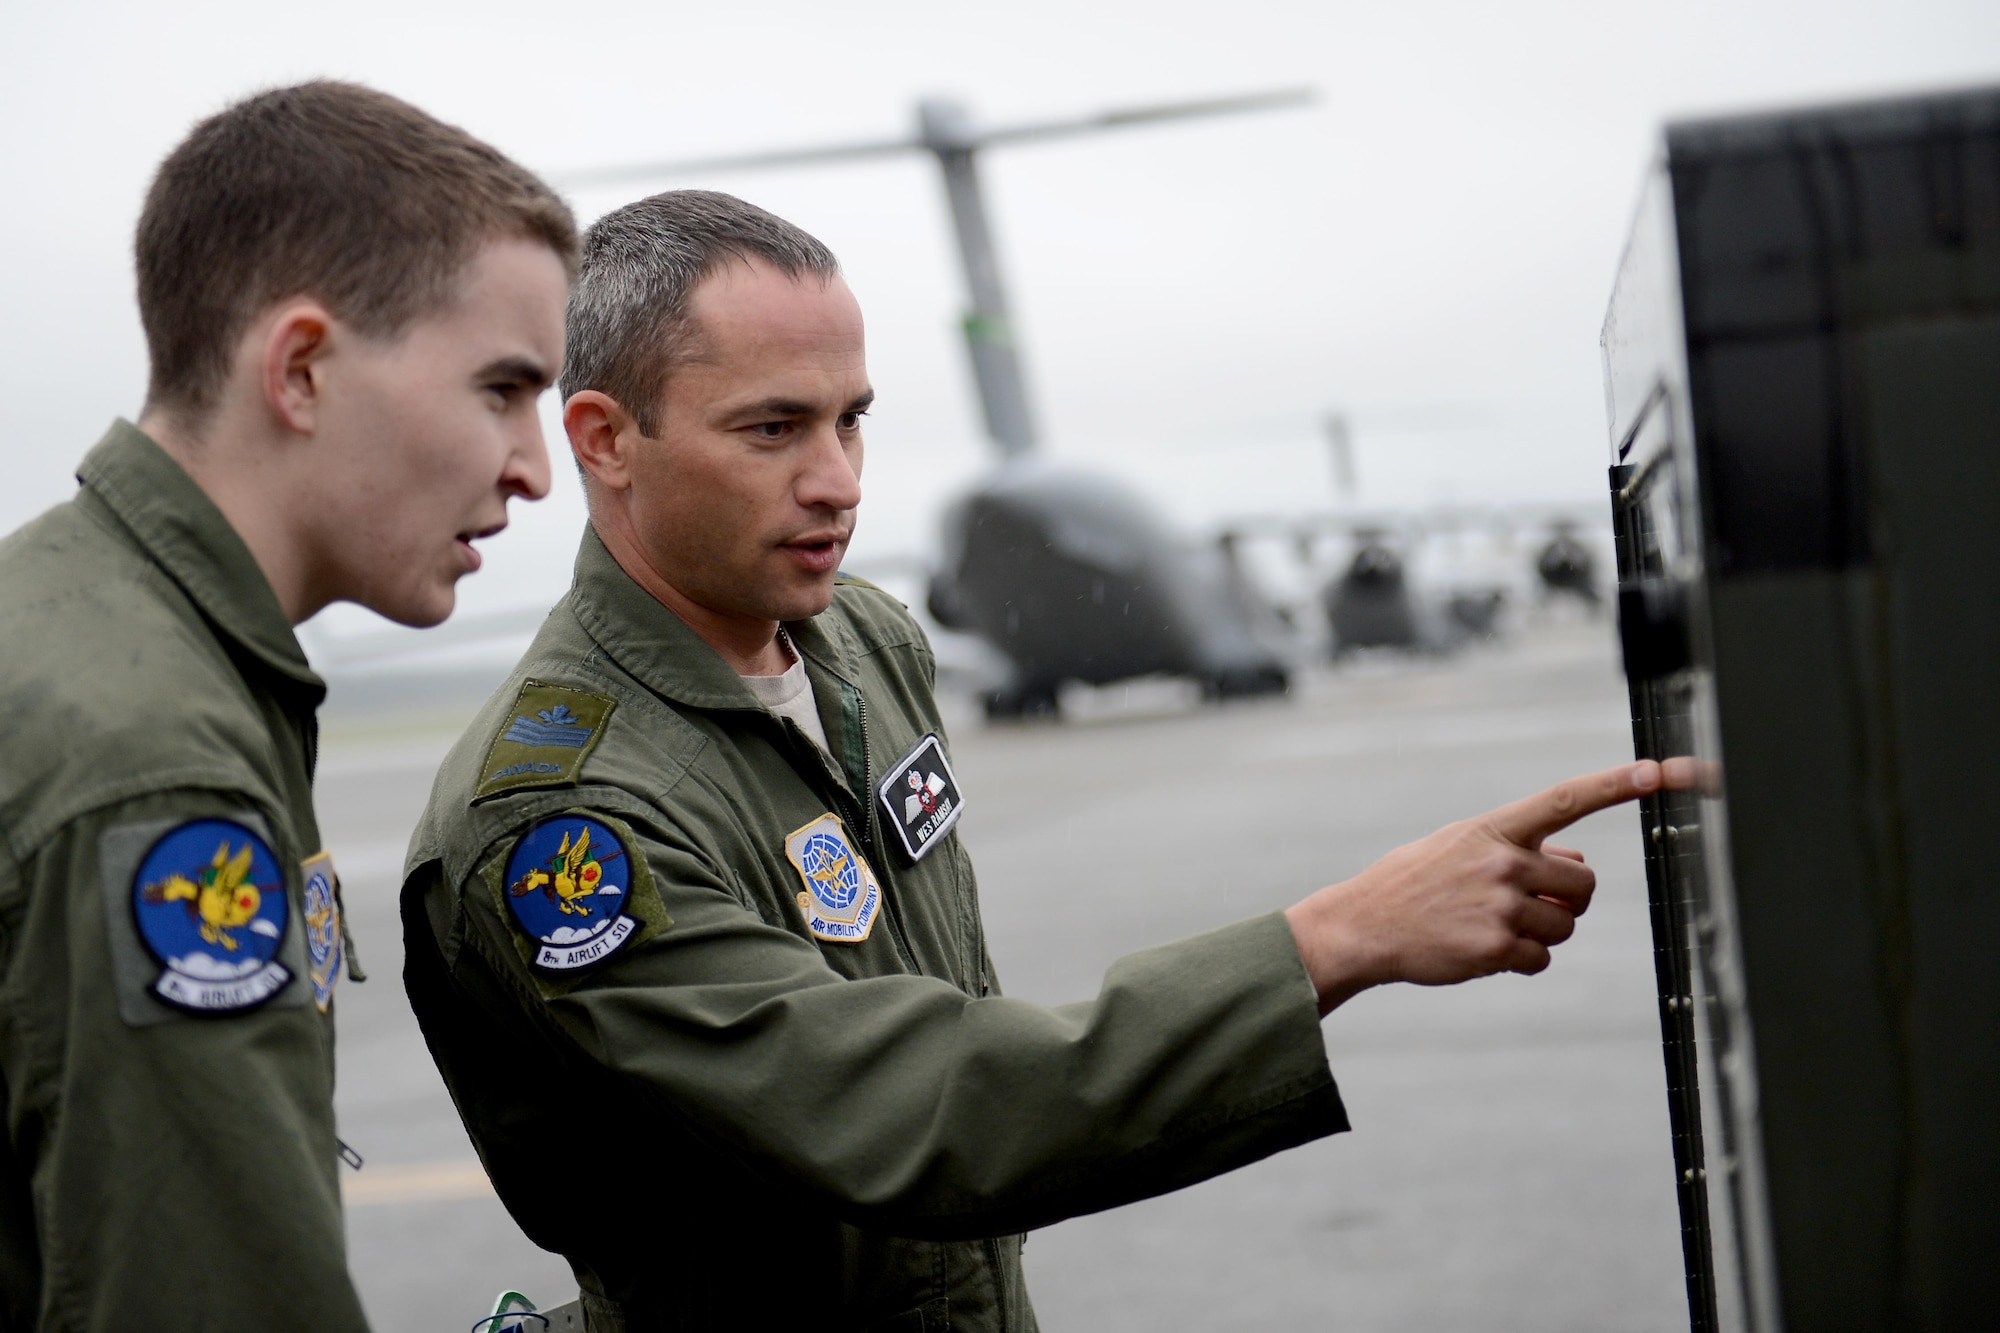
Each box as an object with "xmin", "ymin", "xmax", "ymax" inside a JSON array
[{"xmin": 402, "ymin": 532, "xmax": 1346, "ymax": 1333}]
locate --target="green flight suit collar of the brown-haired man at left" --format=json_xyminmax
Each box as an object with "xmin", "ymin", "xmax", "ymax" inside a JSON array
[{"xmin": 76, "ymin": 420, "xmax": 326, "ymax": 707}]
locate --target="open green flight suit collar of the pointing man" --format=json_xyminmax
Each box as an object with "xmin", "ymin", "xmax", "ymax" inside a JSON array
[{"xmin": 570, "ymin": 526, "xmax": 856, "ymax": 713}]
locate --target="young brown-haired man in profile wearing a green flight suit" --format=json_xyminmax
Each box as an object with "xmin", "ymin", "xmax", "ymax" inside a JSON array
[{"xmin": 0, "ymin": 84, "xmax": 576, "ymax": 1331}]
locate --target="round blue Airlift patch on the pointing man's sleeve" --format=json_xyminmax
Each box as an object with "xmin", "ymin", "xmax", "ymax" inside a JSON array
[{"xmin": 506, "ymin": 815, "xmax": 638, "ymax": 973}]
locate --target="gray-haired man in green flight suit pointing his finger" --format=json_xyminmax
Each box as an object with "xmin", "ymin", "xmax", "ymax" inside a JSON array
[{"xmin": 404, "ymin": 192, "xmax": 1688, "ymax": 1333}]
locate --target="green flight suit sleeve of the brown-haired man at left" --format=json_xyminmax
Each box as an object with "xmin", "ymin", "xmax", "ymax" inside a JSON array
[{"xmin": 0, "ymin": 791, "xmax": 366, "ymax": 1331}]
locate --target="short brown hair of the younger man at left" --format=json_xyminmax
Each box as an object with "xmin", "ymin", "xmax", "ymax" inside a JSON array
[{"xmin": 136, "ymin": 80, "xmax": 576, "ymax": 418}]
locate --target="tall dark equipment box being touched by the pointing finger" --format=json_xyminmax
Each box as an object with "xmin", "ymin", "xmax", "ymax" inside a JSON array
[{"xmin": 1604, "ymin": 90, "xmax": 2000, "ymax": 1333}]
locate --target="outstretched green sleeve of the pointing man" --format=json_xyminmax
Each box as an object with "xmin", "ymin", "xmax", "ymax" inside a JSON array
[{"xmin": 430, "ymin": 788, "xmax": 1346, "ymax": 1239}]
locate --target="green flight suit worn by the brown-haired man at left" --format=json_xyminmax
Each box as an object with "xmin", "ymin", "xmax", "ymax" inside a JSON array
[{"xmin": 0, "ymin": 422, "xmax": 366, "ymax": 1333}]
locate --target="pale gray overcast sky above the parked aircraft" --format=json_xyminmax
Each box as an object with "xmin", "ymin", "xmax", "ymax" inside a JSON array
[{"xmin": 0, "ymin": 0, "xmax": 2000, "ymax": 632}]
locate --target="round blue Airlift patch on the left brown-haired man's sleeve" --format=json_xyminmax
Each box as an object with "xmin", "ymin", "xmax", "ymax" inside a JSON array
[{"xmin": 132, "ymin": 819, "xmax": 292, "ymax": 1013}]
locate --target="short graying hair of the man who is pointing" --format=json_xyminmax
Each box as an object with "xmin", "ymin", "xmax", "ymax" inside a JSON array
[{"xmin": 562, "ymin": 190, "xmax": 840, "ymax": 434}]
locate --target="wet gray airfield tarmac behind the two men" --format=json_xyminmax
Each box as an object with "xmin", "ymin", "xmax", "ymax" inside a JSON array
[{"xmin": 318, "ymin": 622, "xmax": 1686, "ymax": 1333}]
